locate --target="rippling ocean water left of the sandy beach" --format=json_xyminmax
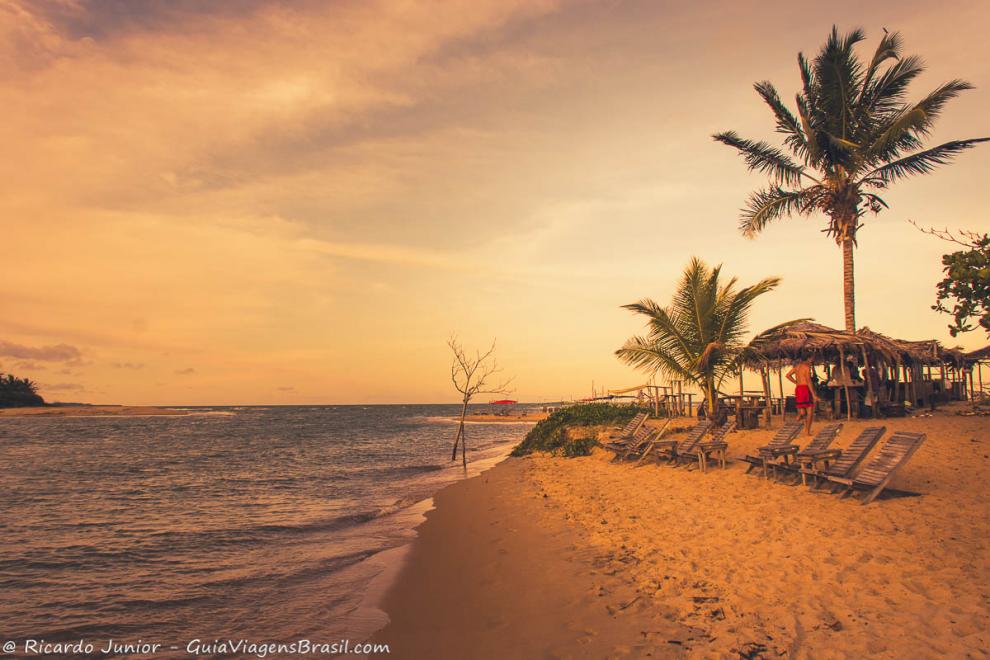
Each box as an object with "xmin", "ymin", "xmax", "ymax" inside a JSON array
[{"xmin": 0, "ymin": 405, "xmax": 530, "ymax": 657}]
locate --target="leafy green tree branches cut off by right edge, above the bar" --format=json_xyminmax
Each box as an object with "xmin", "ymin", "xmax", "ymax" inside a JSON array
[{"xmin": 932, "ymin": 232, "xmax": 990, "ymax": 337}]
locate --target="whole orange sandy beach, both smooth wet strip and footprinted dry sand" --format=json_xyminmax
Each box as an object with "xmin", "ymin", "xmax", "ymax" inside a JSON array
[{"xmin": 377, "ymin": 407, "xmax": 990, "ymax": 658}]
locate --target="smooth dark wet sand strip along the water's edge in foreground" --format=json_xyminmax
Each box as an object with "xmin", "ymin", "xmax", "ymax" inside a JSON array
[{"xmin": 370, "ymin": 457, "xmax": 687, "ymax": 658}]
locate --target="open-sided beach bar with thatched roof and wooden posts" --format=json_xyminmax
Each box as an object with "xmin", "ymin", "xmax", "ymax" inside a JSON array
[{"xmin": 737, "ymin": 320, "xmax": 976, "ymax": 425}]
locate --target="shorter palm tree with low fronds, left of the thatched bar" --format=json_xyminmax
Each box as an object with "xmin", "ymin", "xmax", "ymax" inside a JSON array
[{"xmin": 615, "ymin": 257, "xmax": 780, "ymax": 414}]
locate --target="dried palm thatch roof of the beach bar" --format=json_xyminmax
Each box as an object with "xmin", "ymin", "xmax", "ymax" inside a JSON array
[{"xmin": 740, "ymin": 319, "xmax": 968, "ymax": 368}]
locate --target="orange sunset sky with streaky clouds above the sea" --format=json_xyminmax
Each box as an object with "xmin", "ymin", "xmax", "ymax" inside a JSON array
[{"xmin": 0, "ymin": 0, "xmax": 990, "ymax": 405}]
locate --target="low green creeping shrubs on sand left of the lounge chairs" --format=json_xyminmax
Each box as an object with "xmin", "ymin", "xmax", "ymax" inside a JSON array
[{"xmin": 512, "ymin": 403, "xmax": 639, "ymax": 458}]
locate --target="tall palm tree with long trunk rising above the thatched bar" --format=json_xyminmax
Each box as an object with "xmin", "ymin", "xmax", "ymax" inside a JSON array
[{"xmin": 712, "ymin": 27, "xmax": 990, "ymax": 332}]
